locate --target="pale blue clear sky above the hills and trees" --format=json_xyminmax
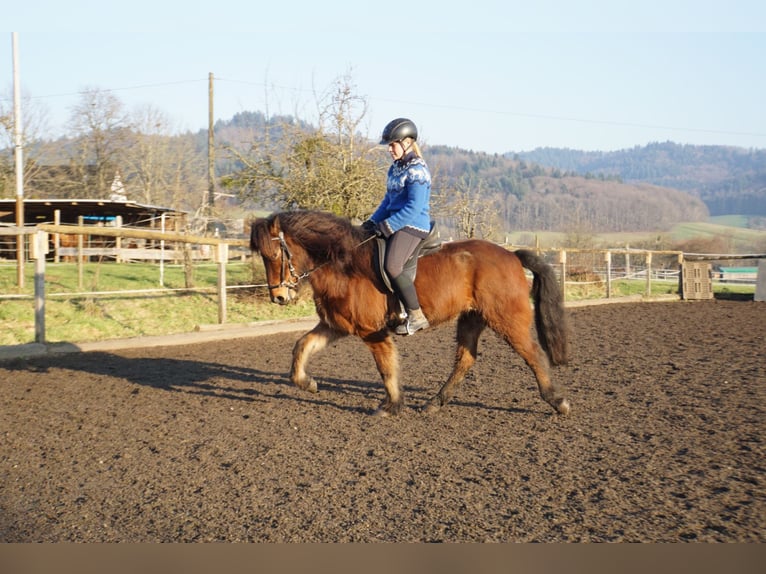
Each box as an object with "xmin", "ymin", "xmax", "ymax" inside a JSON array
[{"xmin": 0, "ymin": 0, "xmax": 766, "ymax": 153}]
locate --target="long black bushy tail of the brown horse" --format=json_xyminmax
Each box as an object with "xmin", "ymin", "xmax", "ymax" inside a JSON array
[{"xmin": 515, "ymin": 249, "xmax": 569, "ymax": 365}]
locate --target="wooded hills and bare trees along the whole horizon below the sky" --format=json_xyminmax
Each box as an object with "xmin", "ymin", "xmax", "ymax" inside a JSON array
[{"xmin": 0, "ymin": 78, "xmax": 748, "ymax": 239}]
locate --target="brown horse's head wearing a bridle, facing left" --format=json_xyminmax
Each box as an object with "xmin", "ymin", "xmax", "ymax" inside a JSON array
[{"xmin": 250, "ymin": 215, "xmax": 301, "ymax": 305}]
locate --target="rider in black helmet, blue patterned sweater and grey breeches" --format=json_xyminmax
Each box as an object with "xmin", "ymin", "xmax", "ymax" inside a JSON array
[{"xmin": 362, "ymin": 118, "xmax": 431, "ymax": 335}]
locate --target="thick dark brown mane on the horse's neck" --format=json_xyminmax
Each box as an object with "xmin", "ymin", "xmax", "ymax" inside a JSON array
[{"xmin": 258, "ymin": 211, "xmax": 372, "ymax": 268}]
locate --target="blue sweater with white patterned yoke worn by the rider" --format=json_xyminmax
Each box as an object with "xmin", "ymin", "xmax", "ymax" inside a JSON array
[{"xmin": 370, "ymin": 153, "xmax": 431, "ymax": 237}]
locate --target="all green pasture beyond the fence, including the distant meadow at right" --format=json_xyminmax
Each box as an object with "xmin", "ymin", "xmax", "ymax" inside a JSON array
[{"xmin": 0, "ymin": 212, "xmax": 766, "ymax": 345}]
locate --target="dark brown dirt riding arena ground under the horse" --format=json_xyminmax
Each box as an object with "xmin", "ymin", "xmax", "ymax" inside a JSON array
[{"xmin": 0, "ymin": 301, "xmax": 766, "ymax": 542}]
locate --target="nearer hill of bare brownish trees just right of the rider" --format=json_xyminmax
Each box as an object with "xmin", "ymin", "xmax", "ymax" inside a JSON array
[{"xmin": 424, "ymin": 146, "xmax": 708, "ymax": 232}]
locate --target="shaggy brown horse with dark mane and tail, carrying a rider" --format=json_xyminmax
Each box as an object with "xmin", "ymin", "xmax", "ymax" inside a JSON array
[{"xmin": 250, "ymin": 211, "xmax": 569, "ymax": 415}]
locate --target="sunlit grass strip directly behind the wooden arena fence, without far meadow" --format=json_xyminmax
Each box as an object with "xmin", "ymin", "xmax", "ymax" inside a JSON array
[{"xmin": 0, "ymin": 262, "xmax": 754, "ymax": 345}]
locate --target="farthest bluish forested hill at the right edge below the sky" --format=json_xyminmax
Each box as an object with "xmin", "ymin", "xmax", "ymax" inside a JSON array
[{"xmin": 513, "ymin": 142, "xmax": 766, "ymax": 216}]
